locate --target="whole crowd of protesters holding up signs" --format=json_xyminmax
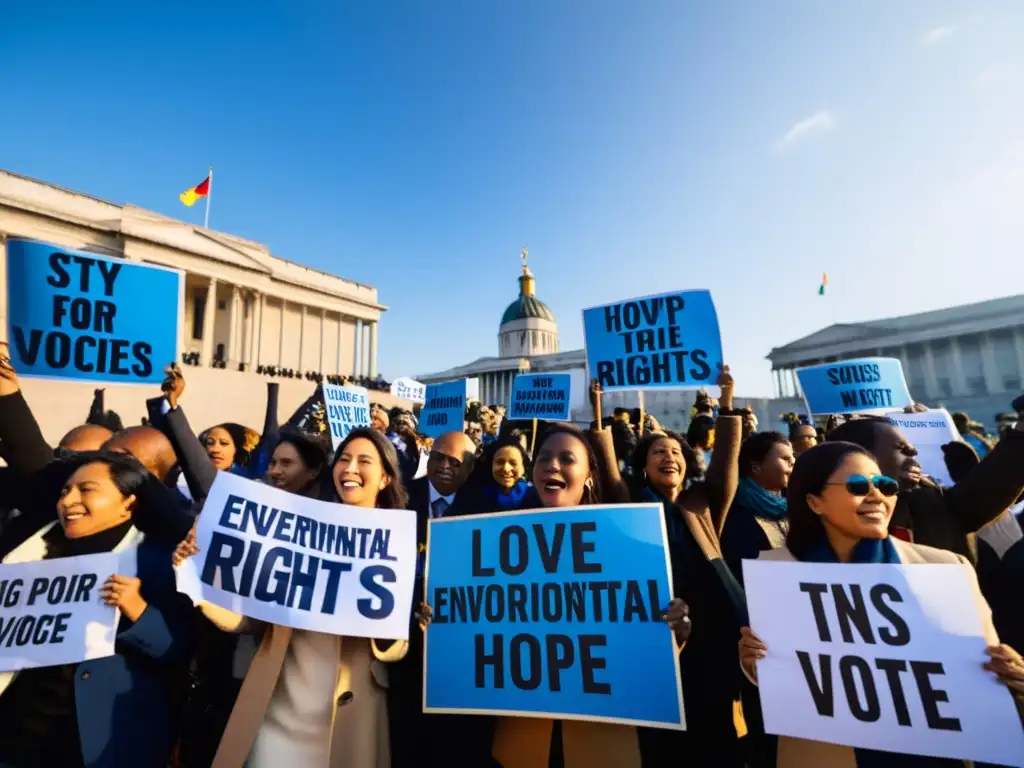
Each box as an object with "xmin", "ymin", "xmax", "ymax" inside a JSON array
[{"xmin": 0, "ymin": 356, "xmax": 1024, "ymax": 768}]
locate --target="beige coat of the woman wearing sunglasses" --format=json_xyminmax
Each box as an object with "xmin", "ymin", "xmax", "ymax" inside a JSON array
[{"xmin": 744, "ymin": 537, "xmax": 999, "ymax": 768}]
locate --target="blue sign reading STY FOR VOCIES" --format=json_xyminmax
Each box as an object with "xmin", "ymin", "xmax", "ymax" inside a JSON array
[{"xmin": 7, "ymin": 238, "xmax": 181, "ymax": 384}]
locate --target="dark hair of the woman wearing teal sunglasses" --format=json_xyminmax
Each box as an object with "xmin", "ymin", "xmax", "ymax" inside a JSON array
[{"xmin": 785, "ymin": 440, "xmax": 874, "ymax": 558}]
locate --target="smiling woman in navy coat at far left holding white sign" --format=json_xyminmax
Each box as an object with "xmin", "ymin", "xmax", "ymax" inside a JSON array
[{"xmin": 0, "ymin": 453, "xmax": 195, "ymax": 768}]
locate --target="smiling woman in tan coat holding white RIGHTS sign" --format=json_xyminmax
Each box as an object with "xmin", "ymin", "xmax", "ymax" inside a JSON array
[{"xmin": 201, "ymin": 429, "xmax": 408, "ymax": 768}]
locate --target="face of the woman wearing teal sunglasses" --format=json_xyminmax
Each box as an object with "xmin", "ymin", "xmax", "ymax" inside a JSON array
[{"xmin": 807, "ymin": 454, "xmax": 898, "ymax": 541}]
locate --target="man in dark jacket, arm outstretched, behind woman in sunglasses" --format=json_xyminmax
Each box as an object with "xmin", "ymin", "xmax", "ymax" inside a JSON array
[{"xmin": 827, "ymin": 401, "xmax": 1024, "ymax": 562}]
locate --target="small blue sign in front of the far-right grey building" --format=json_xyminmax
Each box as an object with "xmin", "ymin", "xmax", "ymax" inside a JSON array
[{"xmin": 797, "ymin": 357, "xmax": 913, "ymax": 416}]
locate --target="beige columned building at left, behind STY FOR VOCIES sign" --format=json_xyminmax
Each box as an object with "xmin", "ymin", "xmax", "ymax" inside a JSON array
[{"xmin": 0, "ymin": 171, "xmax": 408, "ymax": 442}]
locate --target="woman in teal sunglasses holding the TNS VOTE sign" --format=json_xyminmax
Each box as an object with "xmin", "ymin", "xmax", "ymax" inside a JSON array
[{"xmin": 739, "ymin": 442, "xmax": 1024, "ymax": 768}]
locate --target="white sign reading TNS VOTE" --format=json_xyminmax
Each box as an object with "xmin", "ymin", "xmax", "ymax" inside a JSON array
[{"xmin": 743, "ymin": 560, "xmax": 1024, "ymax": 766}]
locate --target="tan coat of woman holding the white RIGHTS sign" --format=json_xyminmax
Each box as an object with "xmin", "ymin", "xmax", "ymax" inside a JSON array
[{"xmin": 201, "ymin": 603, "xmax": 409, "ymax": 768}]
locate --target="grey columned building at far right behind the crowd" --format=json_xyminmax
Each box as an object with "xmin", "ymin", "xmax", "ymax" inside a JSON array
[{"xmin": 768, "ymin": 296, "xmax": 1024, "ymax": 427}]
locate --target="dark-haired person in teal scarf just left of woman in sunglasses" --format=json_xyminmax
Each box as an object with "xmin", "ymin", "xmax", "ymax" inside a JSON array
[{"xmin": 722, "ymin": 432, "xmax": 794, "ymax": 584}]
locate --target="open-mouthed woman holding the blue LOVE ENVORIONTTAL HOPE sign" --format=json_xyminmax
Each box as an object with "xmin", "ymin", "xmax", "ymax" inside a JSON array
[{"xmin": 494, "ymin": 424, "xmax": 688, "ymax": 768}]
